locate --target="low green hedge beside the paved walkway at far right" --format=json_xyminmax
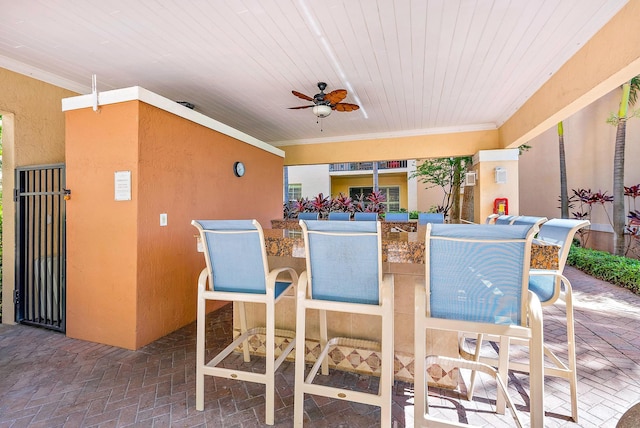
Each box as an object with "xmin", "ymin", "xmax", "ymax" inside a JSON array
[{"xmin": 567, "ymin": 245, "xmax": 640, "ymax": 294}]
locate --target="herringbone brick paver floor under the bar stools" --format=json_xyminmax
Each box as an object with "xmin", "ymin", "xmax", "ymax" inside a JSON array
[{"xmin": 0, "ymin": 267, "xmax": 640, "ymax": 428}]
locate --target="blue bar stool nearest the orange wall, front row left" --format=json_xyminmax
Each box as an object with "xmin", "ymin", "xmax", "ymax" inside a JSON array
[{"xmin": 191, "ymin": 220, "xmax": 298, "ymax": 425}]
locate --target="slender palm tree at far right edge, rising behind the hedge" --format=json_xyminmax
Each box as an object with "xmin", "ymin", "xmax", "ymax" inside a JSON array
[{"xmin": 612, "ymin": 75, "xmax": 640, "ymax": 256}]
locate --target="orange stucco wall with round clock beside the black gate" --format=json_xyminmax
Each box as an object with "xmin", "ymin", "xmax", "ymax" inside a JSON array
[{"xmin": 66, "ymin": 101, "xmax": 283, "ymax": 349}]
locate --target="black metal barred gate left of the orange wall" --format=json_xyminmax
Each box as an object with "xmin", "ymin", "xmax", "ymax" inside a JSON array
[{"xmin": 14, "ymin": 164, "xmax": 66, "ymax": 332}]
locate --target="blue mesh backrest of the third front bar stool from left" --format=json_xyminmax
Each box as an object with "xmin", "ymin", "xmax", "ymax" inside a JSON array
[{"xmin": 425, "ymin": 224, "xmax": 533, "ymax": 325}]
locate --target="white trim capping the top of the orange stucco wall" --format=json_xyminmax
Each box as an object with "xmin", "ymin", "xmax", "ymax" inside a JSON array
[{"xmin": 62, "ymin": 86, "xmax": 284, "ymax": 158}]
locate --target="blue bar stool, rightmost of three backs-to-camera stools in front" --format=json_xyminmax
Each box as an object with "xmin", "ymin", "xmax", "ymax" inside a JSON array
[{"xmin": 414, "ymin": 224, "xmax": 544, "ymax": 428}]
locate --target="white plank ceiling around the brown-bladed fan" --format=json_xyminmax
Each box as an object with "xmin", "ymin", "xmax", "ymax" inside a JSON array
[{"xmin": 0, "ymin": 0, "xmax": 626, "ymax": 146}]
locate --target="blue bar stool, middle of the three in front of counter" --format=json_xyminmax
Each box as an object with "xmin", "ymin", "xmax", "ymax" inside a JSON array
[{"xmin": 294, "ymin": 220, "xmax": 394, "ymax": 428}]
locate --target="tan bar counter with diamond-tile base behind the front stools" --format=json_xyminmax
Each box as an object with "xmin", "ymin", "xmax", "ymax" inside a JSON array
[{"xmin": 234, "ymin": 220, "xmax": 557, "ymax": 389}]
